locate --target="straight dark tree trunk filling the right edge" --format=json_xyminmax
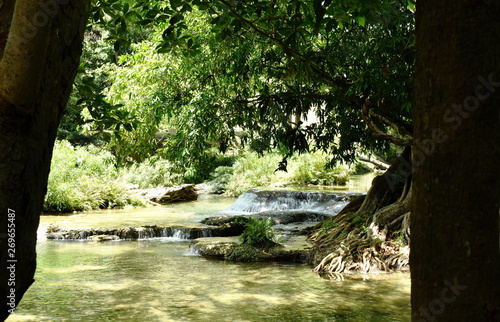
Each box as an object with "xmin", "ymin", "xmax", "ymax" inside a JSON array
[{"xmin": 410, "ymin": 0, "xmax": 500, "ymax": 321}]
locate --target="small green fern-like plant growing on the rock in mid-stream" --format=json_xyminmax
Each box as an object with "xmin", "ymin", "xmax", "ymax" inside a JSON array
[{"xmin": 240, "ymin": 217, "xmax": 277, "ymax": 249}]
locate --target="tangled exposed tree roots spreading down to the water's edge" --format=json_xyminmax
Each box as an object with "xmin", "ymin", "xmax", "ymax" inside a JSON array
[{"xmin": 310, "ymin": 167, "xmax": 411, "ymax": 280}]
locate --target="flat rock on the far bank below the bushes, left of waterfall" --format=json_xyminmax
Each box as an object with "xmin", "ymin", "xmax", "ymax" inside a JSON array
[{"xmin": 141, "ymin": 184, "xmax": 198, "ymax": 204}]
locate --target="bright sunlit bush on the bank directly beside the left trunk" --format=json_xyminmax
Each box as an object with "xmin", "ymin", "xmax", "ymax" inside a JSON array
[{"xmin": 44, "ymin": 141, "xmax": 145, "ymax": 212}]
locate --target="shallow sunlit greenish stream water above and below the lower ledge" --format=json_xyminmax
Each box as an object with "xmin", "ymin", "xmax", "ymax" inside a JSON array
[{"xmin": 7, "ymin": 175, "xmax": 411, "ymax": 321}]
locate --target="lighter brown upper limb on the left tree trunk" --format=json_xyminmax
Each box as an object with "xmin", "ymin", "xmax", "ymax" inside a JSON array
[{"xmin": 0, "ymin": 0, "xmax": 53, "ymax": 114}]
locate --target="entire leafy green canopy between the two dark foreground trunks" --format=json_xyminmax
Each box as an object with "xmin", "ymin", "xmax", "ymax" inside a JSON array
[{"xmin": 65, "ymin": 0, "xmax": 414, "ymax": 174}]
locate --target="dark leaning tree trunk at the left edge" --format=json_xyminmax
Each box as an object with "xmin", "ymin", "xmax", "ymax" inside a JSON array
[{"xmin": 0, "ymin": 0, "xmax": 89, "ymax": 320}]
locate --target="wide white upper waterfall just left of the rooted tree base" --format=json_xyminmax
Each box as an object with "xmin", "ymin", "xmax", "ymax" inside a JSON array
[{"xmin": 223, "ymin": 189, "xmax": 356, "ymax": 215}]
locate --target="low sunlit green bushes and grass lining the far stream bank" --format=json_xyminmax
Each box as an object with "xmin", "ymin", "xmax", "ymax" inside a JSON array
[{"xmin": 44, "ymin": 141, "xmax": 370, "ymax": 212}]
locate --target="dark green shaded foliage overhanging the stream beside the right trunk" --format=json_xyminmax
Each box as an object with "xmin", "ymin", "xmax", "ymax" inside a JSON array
[{"xmin": 150, "ymin": 1, "xmax": 414, "ymax": 162}]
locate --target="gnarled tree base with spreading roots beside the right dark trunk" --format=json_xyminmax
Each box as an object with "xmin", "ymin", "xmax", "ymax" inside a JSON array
[{"xmin": 310, "ymin": 147, "xmax": 411, "ymax": 277}]
